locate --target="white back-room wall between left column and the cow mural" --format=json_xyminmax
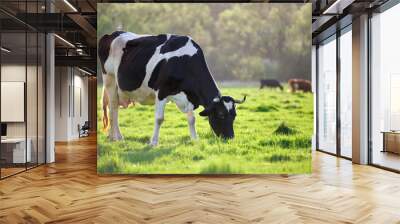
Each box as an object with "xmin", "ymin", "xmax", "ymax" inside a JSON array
[{"xmin": 55, "ymin": 67, "xmax": 88, "ymax": 141}]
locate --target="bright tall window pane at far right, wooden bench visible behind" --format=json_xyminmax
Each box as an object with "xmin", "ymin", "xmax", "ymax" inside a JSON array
[{"xmin": 371, "ymin": 4, "xmax": 400, "ymax": 170}]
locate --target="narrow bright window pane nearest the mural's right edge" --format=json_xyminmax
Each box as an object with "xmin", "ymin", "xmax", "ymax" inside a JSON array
[{"xmin": 317, "ymin": 36, "xmax": 336, "ymax": 153}]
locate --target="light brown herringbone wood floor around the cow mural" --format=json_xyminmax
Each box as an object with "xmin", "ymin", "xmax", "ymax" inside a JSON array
[{"xmin": 0, "ymin": 137, "xmax": 400, "ymax": 223}]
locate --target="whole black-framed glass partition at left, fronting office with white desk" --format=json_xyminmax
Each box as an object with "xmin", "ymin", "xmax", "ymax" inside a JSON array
[{"xmin": 0, "ymin": 1, "xmax": 46, "ymax": 179}]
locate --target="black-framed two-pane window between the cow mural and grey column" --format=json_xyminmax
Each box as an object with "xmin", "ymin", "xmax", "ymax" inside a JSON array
[{"xmin": 316, "ymin": 21, "xmax": 352, "ymax": 159}]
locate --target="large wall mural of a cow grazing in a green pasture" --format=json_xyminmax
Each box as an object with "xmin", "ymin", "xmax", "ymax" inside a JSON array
[{"xmin": 97, "ymin": 3, "xmax": 313, "ymax": 174}]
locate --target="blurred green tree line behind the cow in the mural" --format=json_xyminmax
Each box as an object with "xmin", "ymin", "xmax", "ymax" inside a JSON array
[{"xmin": 97, "ymin": 3, "xmax": 311, "ymax": 81}]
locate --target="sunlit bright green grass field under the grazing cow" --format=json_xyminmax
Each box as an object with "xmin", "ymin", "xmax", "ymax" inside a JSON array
[{"xmin": 97, "ymin": 87, "xmax": 313, "ymax": 174}]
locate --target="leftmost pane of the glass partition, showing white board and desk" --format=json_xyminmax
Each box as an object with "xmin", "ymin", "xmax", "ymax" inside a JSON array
[{"xmin": 0, "ymin": 32, "xmax": 27, "ymax": 177}]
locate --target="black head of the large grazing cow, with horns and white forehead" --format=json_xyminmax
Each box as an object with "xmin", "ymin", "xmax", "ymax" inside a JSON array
[{"xmin": 200, "ymin": 96, "xmax": 246, "ymax": 139}]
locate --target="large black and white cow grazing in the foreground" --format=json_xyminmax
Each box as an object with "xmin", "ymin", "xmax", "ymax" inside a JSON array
[{"xmin": 98, "ymin": 31, "xmax": 245, "ymax": 145}]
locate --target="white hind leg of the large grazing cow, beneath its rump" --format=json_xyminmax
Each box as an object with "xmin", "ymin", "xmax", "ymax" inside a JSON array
[{"xmin": 103, "ymin": 75, "xmax": 122, "ymax": 141}]
